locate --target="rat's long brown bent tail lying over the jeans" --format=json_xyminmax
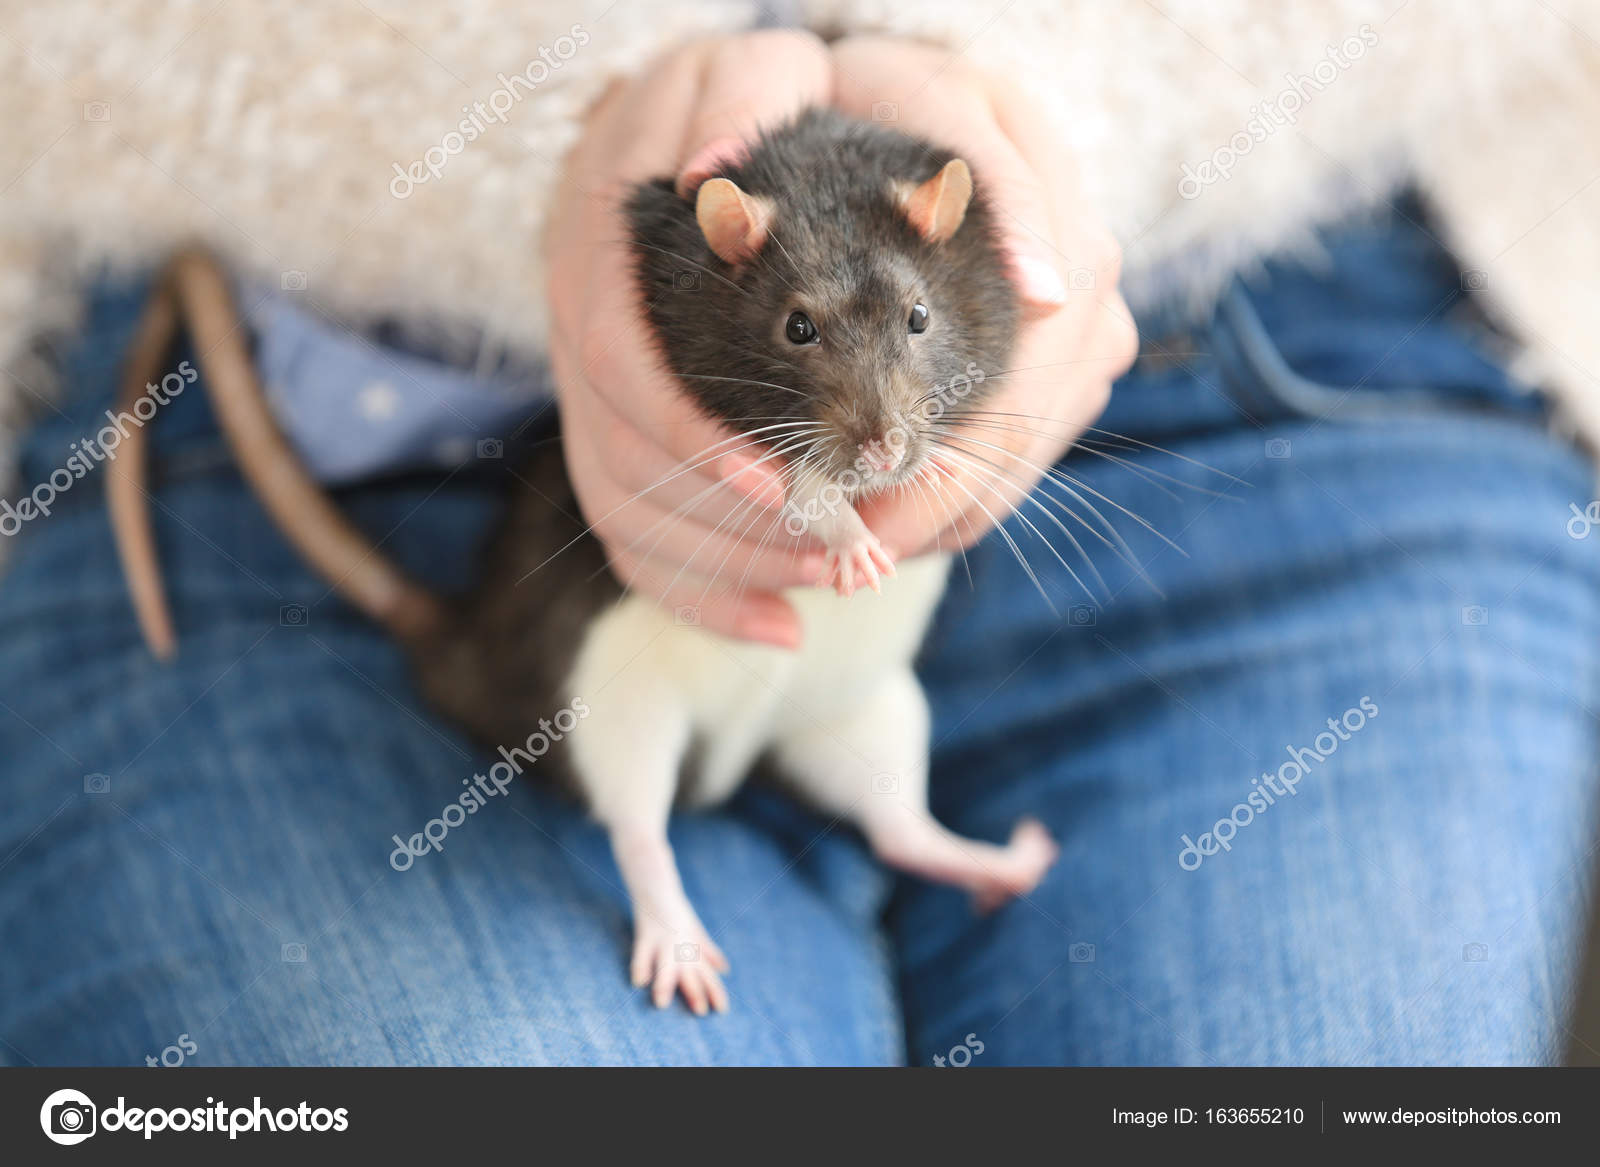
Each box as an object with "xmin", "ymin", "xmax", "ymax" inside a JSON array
[{"xmin": 106, "ymin": 250, "xmax": 443, "ymax": 660}]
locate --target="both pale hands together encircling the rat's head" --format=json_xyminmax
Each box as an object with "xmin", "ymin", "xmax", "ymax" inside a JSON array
[{"xmin": 547, "ymin": 30, "xmax": 1138, "ymax": 648}]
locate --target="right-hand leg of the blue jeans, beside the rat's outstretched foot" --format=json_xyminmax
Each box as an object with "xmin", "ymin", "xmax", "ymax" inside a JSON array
[{"xmin": 893, "ymin": 197, "xmax": 1600, "ymax": 1065}]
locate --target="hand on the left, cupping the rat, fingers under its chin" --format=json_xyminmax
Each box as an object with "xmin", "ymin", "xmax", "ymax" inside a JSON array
[{"xmin": 546, "ymin": 32, "xmax": 832, "ymax": 647}]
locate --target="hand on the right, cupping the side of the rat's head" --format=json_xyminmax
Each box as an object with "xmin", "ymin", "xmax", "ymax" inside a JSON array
[{"xmin": 832, "ymin": 37, "xmax": 1138, "ymax": 557}]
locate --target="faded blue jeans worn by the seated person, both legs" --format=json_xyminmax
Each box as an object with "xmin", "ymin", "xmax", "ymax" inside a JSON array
[{"xmin": 0, "ymin": 208, "xmax": 1600, "ymax": 1065}]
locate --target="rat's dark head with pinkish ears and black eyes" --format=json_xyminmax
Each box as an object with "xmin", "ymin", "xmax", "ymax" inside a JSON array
[{"xmin": 634, "ymin": 118, "xmax": 1018, "ymax": 493}]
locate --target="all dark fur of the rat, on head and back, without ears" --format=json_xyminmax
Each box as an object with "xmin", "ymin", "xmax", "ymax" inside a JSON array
[{"xmin": 414, "ymin": 110, "xmax": 1019, "ymax": 784}]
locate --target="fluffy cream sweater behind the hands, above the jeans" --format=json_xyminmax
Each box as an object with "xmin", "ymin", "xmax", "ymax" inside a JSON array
[{"xmin": 0, "ymin": 0, "xmax": 1600, "ymax": 499}]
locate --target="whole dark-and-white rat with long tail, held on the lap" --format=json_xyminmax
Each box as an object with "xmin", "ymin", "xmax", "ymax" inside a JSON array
[{"xmin": 109, "ymin": 109, "xmax": 1058, "ymax": 1015}]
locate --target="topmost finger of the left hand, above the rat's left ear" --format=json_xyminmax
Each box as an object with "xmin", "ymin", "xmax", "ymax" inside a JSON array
[{"xmin": 678, "ymin": 29, "xmax": 834, "ymax": 195}]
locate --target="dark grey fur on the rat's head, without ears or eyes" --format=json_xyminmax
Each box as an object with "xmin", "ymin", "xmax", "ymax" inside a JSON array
[{"xmin": 627, "ymin": 109, "xmax": 1019, "ymax": 472}]
